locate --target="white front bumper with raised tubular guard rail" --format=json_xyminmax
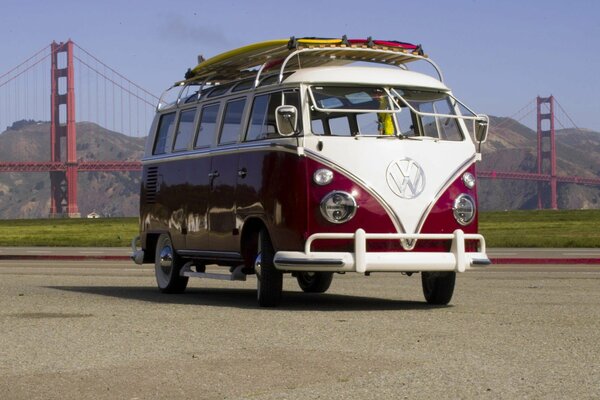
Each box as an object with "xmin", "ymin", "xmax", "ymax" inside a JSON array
[{"xmin": 274, "ymin": 229, "xmax": 491, "ymax": 273}]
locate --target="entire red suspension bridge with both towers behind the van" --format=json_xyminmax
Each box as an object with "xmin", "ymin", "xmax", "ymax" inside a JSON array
[{"xmin": 0, "ymin": 40, "xmax": 600, "ymax": 217}]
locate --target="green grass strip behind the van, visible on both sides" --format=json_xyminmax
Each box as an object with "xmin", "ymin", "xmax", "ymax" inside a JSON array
[{"xmin": 0, "ymin": 210, "xmax": 600, "ymax": 248}]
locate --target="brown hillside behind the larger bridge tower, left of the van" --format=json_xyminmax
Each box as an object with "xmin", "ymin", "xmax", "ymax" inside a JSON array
[{"xmin": 0, "ymin": 121, "xmax": 145, "ymax": 219}]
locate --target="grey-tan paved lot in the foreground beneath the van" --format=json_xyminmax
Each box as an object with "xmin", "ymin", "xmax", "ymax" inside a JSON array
[{"xmin": 0, "ymin": 261, "xmax": 600, "ymax": 399}]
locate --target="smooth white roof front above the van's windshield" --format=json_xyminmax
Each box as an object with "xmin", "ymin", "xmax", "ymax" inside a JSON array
[{"xmin": 284, "ymin": 66, "xmax": 450, "ymax": 91}]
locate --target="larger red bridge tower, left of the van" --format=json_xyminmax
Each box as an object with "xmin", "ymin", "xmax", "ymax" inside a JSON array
[{"xmin": 50, "ymin": 40, "xmax": 81, "ymax": 218}]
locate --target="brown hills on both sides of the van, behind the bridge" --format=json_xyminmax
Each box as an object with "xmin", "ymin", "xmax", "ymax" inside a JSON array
[{"xmin": 0, "ymin": 117, "xmax": 600, "ymax": 219}]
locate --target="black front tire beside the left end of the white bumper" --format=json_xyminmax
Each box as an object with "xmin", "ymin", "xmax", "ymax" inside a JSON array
[{"xmin": 254, "ymin": 229, "xmax": 283, "ymax": 307}]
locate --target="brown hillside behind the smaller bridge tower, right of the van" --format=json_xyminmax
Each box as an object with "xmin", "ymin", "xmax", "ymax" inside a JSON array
[{"xmin": 478, "ymin": 117, "xmax": 600, "ymax": 210}]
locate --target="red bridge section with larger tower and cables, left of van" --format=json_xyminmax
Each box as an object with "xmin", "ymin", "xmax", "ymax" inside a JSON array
[{"xmin": 0, "ymin": 40, "xmax": 158, "ymax": 217}]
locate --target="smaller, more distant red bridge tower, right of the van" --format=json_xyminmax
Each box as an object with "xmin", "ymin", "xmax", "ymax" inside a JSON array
[{"xmin": 537, "ymin": 96, "xmax": 558, "ymax": 210}]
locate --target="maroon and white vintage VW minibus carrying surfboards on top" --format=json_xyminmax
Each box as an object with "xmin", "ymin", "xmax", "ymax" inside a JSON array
[{"xmin": 132, "ymin": 37, "xmax": 490, "ymax": 307}]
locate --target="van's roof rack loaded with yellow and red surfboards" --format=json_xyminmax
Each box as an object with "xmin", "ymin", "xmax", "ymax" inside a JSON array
[{"xmin": 175, "ymin": 36, "xmax": 443, "ymax": 86}]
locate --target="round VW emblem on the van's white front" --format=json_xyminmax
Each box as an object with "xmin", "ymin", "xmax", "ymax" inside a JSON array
[{"xmin": 385, "ymin": 158, "xmax": 425, "ymax": 199}]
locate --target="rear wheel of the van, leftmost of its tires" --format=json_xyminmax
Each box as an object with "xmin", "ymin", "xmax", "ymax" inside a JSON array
[{"xmin": 154, "ymin": 233, "xmax": 188, "ymax": 293}]
